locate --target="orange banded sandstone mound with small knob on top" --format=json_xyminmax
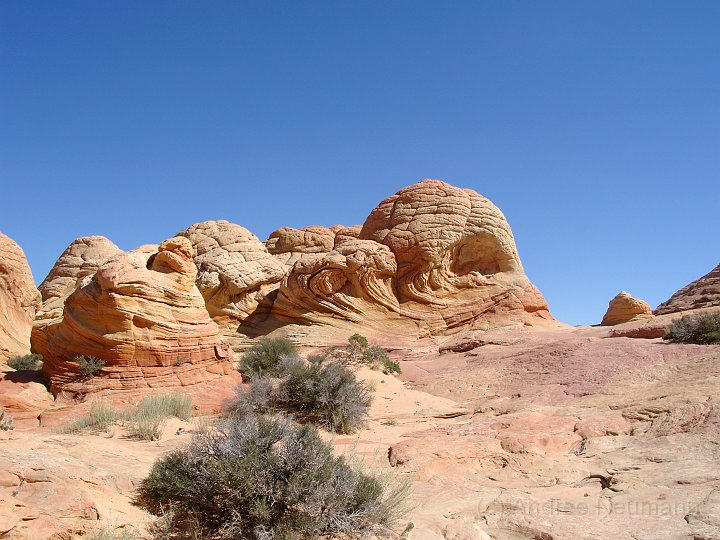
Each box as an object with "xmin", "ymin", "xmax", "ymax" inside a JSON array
[{"xmin": 43, "ymin": 237, "xmax": 232, "ymax": 393}]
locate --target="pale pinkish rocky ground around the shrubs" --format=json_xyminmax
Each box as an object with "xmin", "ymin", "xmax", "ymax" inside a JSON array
[{"xmin": 0, "ymin": 314, "xmax": 720, "ymax": 540}]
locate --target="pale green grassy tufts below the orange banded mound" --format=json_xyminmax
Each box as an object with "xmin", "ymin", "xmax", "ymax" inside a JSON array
[{"xmin": 63, "ymin": 393, "xmax": 193, "ymax": 441}]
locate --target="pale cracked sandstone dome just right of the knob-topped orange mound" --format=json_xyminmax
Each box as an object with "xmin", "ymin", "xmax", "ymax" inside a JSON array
[{"xmin": 179, "ymin": 221, "xmax": 286, "ymax": 338}]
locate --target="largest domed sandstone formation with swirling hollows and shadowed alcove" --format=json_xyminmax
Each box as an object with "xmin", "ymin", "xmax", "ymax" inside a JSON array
[{"xmin": 268, "ymin": 180, "xmax": 552, "ymax": 339}]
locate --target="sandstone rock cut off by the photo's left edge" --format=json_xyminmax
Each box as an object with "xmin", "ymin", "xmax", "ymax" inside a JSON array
[{"xmin": 0, "ymin": 233, "xmax": 40, "ymax": 362}]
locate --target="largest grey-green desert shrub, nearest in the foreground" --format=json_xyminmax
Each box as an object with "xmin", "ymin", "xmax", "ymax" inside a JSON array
[{"xmin": 139, "ymin": 415, "xmax": 404, "ymax": 540}]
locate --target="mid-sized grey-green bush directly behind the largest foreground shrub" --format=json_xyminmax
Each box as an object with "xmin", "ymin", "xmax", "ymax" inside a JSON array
[{"xmin": 228, "ymin": 356, "xmax": 371, "ymax": 433}]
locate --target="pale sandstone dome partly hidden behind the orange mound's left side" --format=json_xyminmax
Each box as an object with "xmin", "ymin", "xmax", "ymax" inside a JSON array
[{"xmin": 32, "ymin": 236, "xmax": 122, "ymax": 355}]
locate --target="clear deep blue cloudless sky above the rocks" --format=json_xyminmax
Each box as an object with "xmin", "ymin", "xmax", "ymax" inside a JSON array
[{"xmin": 0, "ymin": 0, "xmax": 720, "ymax": 324}]
